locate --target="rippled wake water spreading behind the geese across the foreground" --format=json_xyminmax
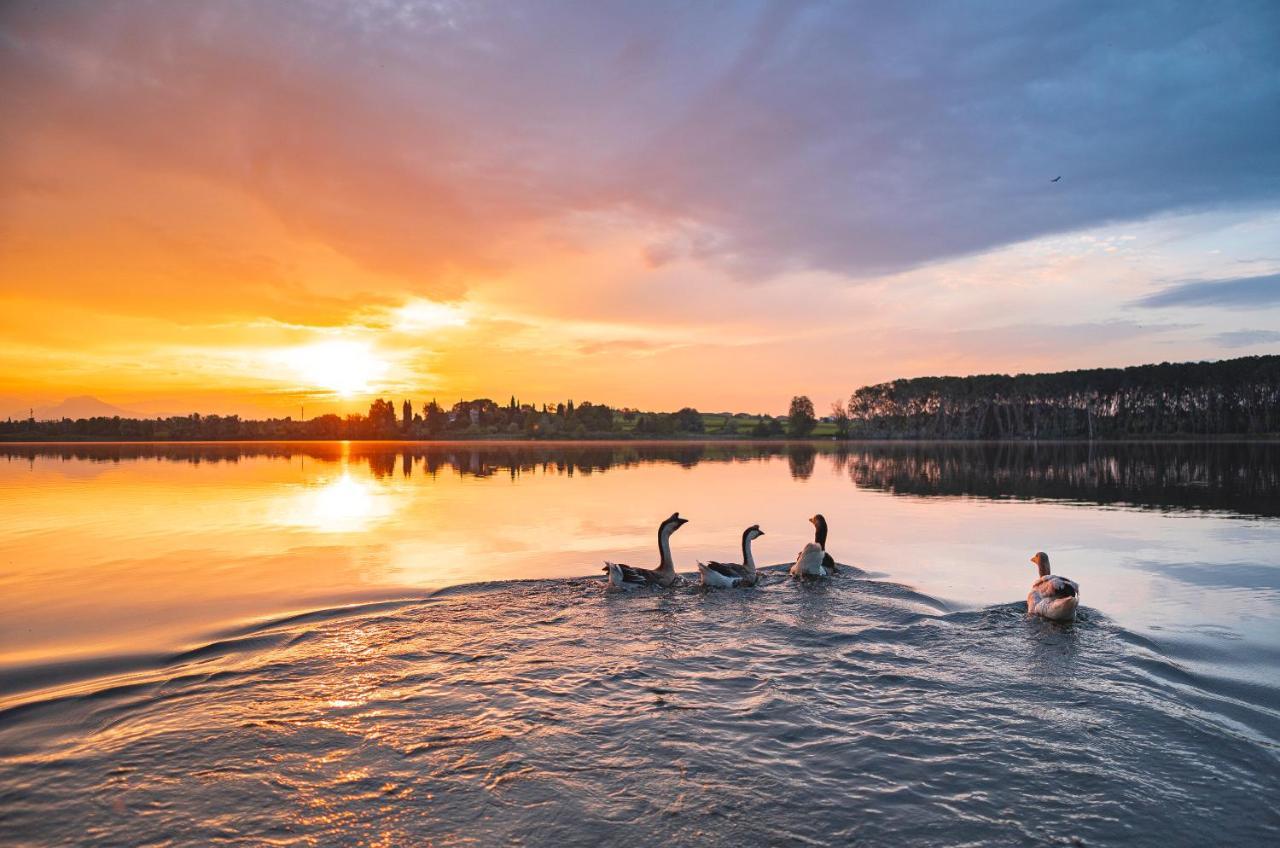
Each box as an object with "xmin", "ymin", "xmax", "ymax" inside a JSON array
[{"xmin": 0, "ymin": 566, "xmax": 1280, "ymax": 845}]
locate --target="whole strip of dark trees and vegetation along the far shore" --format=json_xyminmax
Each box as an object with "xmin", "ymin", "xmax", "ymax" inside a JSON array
[{"xmin": 0, "ymin": 356, "xmax": 1280, "ymax": 442}]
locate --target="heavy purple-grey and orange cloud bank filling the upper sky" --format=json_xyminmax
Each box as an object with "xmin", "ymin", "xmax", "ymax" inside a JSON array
[{"xmin": 0, "ymin": 0, "xmax": 1280, "ymax": 279}]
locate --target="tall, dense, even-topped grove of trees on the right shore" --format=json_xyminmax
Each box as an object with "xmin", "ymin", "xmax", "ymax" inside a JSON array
[{"xmin": 832, "ymin": 356, "xmax": 1280, "ymax": 439}]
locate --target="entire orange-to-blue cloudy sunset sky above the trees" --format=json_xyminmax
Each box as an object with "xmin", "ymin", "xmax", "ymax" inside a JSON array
[{"xmin": 0, "ymin": 0, "xmax": 1280, "ymax": 415}]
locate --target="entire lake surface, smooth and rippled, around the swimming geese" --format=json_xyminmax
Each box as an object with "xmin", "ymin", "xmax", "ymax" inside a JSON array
[{"xmin": 0, "ymin": 443, "xmax": 1280, "ymax": 845}]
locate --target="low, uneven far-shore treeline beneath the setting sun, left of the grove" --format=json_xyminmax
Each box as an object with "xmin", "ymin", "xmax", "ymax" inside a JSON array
[{"xmin": 0, "ymin": 396, "xmax": 721, "ymax": 441}]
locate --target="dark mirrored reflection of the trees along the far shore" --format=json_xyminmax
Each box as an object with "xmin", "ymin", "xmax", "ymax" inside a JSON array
[{"xmin": 10, "ymin": 441, "xmax": 1280, "ymax": 516}]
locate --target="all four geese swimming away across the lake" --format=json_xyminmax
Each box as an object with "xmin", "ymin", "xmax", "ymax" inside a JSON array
[{"xmin": 604, "ymin": 512, "xmax": 1080, "ymax": 621}]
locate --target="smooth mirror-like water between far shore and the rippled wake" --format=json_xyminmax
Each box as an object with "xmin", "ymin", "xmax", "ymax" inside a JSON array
[{"xmin": 0, "ymin": 443, "xmax": 1280, "ymax": 698}]
